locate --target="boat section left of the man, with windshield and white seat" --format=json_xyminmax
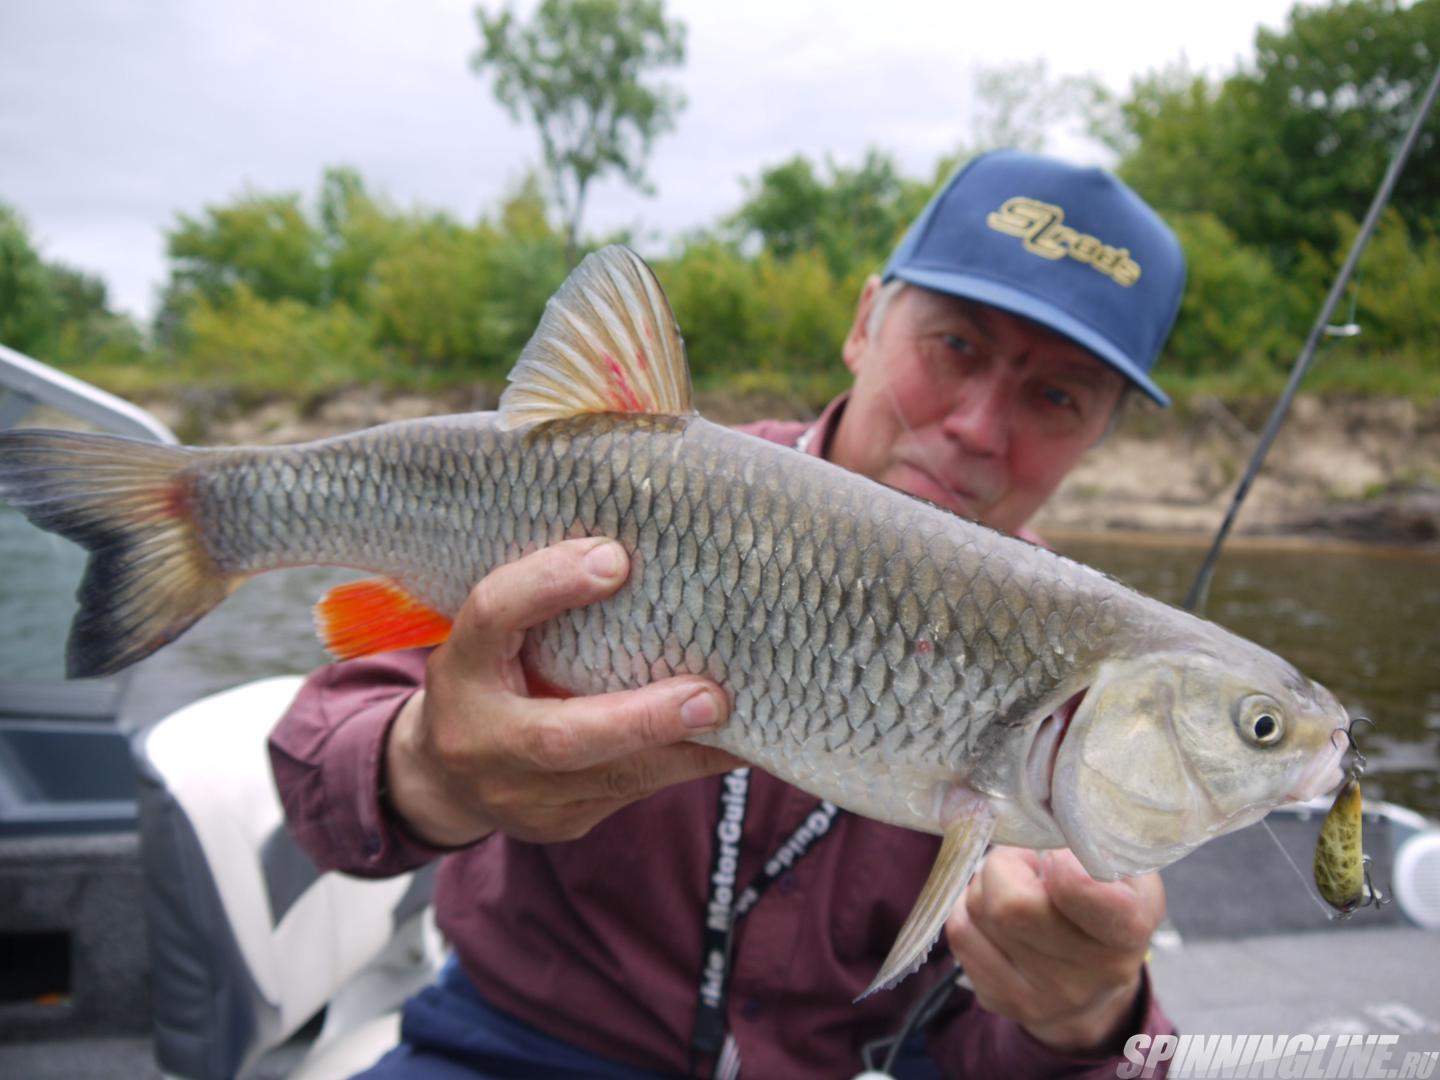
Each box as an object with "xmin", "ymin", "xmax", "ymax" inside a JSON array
[{"xmin": 0, "ymin": 346, "xmax": 444, "ymax": 1080}]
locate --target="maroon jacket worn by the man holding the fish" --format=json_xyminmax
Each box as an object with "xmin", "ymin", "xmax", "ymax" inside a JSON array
[{"xmin": 271, "ymin": 399, "xmax": 1172, "ymax": 1080}]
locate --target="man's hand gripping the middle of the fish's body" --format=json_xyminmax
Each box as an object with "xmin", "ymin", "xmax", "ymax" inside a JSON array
[{"xmin": 384, "ymin": 539, "xmax": 740, "ymax": 847}]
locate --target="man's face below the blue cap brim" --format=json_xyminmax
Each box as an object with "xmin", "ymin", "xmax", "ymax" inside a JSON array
[{"xmin": 829, "ymin": 279, "xmax": 1125, "ymax": 533}]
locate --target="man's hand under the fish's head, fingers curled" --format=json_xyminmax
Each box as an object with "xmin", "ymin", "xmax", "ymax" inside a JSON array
[{"xmin": 945, "ymin": 848, "xmax": 1165, "ymax": 1053}]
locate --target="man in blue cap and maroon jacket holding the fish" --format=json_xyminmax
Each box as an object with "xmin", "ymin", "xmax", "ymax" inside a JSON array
[{"xmin": 272, "ymin": 153, "xmax": 1184, "ymax": 1077}]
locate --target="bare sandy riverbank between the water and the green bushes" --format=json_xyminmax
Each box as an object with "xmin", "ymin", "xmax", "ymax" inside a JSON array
[{"xmin": 144, "ymin": 389, "xmax": 1440, "ymax": 550}]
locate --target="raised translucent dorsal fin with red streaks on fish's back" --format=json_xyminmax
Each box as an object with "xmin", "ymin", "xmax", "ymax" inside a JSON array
[{"xmin": 500, "ymin": 245, "xmax": 694, "ymax": 428}]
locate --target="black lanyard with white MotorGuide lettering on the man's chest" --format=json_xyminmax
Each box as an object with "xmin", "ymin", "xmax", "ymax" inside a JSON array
[{"xmin": 690, "ymin": 766, "xmax": 840, "ymax": 1076}]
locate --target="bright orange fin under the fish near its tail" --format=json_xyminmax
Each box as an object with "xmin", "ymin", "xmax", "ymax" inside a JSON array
[{"xmin": 315, "ymin": 577, "xmax": 452, "ymax": 660}]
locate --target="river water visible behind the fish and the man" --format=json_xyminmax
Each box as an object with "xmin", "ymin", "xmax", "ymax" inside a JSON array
[{"xmin": 0, "ymin": 507, "xmax": 1440, "ymax": 818}]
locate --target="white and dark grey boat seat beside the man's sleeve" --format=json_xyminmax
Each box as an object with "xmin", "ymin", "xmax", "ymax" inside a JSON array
[{"xmin": 135, "ymin": 677, "xmax": 442, "ymax": 1080}]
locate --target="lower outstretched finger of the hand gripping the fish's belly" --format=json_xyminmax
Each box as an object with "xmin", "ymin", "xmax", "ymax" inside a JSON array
[{"xmin": 514, "ymin": 675, "xmax": 730, "ymax": 772}]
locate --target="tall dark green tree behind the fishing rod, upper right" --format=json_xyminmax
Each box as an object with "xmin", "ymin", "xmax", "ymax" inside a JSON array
[{"xmin": 1110, "ymin": 0, "xmax": 1440, "ymax": 268}]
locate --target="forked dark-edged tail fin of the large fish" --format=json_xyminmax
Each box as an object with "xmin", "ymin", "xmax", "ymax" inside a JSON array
[{"xmin": 0, "ymin": 429, "xmax": 233, "ymax": 678}]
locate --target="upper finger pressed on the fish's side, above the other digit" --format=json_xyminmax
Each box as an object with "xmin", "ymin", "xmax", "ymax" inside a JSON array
[{"xmin": 452, "ymin": 537, "xmax": 629, "ymax": 665}]
